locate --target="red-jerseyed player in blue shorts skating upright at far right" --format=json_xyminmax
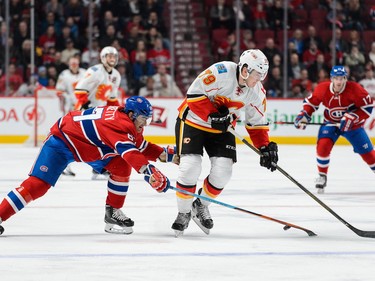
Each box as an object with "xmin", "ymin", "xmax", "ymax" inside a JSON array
[{"xmin": 294, "ymin": 66, "xmax": 375, "ymax": 193}]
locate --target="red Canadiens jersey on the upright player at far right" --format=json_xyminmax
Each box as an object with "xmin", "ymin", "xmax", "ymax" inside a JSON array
[{"xmin": 303, "ymin": 81, "xmax": 373, "ymax": 128}]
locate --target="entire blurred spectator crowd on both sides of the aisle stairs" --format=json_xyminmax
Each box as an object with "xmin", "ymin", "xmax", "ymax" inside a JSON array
[{"xmin": 0, "ymin": 0, "xmax": 375, "ymax": 98}]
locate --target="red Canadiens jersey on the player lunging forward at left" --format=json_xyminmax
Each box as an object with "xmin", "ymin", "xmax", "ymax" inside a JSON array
[{"xmin": 51, "ymin": 106, "xmax": 163, "ymax": 172}]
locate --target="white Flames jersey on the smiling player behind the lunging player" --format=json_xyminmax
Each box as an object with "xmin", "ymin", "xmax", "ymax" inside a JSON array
[{"xmin": 75, "ymin": 64, "xmax": 121, "ymax": 107}]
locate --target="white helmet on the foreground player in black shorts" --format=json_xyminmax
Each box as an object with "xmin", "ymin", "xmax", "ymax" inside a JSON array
[{"xmin": 238, "ymin": 49, "xmax": 269, "ymax": 81}]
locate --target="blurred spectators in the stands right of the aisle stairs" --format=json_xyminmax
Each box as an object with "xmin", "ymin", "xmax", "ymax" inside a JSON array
[{"xmin": 210, "ymin": 0, "xmax": 375, "ymax": 97}]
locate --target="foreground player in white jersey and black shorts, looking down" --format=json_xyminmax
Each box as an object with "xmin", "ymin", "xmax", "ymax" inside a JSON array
[{"xmin": 172, "ymin": 49, "xmax": 278, "ymax": 237}]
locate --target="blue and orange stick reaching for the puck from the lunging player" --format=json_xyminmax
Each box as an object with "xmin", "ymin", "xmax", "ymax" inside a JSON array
[{"xmin": 169, "ymin": 186, "xmax": 317, "ymax": 236}]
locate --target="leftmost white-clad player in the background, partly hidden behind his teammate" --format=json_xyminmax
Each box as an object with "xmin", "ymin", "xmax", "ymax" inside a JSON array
[{"xmin": 56, "ymin": 57, "xmax": 86, "ymax": 177}]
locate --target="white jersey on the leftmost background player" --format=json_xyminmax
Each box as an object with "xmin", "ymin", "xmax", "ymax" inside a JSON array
[{"xmin": 56, "ymin": 68, "xmax": 86, "ymax": 112}]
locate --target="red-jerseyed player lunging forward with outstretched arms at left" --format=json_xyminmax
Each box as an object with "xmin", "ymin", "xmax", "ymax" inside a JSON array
[{"xmin": 0, "ymin": 96, "xmax": 176, "ymax": 234}]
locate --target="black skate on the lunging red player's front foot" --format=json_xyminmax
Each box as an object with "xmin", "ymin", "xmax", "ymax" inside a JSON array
[{"xmin": 104, "ymin": 205, "xmax": 134, "ymax": 234}]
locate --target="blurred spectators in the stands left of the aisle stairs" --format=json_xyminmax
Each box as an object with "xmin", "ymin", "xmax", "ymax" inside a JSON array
[{"xmin": 0, "ymin": 0, "xmax": 182, "ymax": 96}]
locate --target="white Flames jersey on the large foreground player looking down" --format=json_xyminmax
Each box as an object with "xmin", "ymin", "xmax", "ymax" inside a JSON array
[{"xmin": 179, "ymin": 61, "xmax": 268, "ymax": 131}]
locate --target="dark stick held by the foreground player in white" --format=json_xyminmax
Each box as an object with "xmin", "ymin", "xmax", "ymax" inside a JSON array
[{"xmin": 228, "ymin": 128, "xmax": 375, "ymax": 238}]
